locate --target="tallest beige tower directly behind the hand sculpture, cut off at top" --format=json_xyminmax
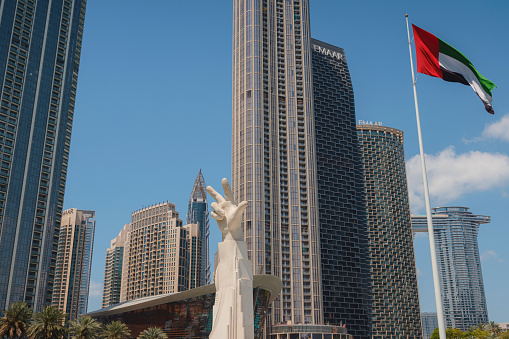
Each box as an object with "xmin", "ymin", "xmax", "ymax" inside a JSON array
[{"xmin": 232, "ymin": 0, "xmax": 323, "ymax": 335}]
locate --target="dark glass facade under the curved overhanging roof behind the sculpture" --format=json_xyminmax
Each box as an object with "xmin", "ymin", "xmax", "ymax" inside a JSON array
[{"xmin": 93, "ymin": 285, "xmax": 271, "ymax": 339}]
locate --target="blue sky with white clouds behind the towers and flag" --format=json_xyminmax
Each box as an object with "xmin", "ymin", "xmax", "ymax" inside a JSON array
[{"xmin": 64, "ymin": 0, "xmax": 509, "ymax": 322}]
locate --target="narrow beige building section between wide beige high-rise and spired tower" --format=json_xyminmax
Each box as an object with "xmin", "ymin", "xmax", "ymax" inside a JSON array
[{"xmin": 182, "ymin": 224, "xmax": 199, "ymax": 289}]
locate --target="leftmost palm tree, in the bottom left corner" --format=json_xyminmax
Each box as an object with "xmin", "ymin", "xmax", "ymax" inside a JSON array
[{"xmin": 0, "ymin": 302, "xmax": 33, "ymax": 338}]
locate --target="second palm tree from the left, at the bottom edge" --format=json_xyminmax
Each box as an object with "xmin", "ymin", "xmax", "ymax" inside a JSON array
[{"xmin": 27, "ymin": 305, "xmax": 67, "ymax": 339}]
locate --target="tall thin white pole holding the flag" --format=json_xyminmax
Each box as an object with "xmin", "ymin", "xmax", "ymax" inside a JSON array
[{"xmin": 405, "ymin": 14, "xmax": 446, "ymax": 339}]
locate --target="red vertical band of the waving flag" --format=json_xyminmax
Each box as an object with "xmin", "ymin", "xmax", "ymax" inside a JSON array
[{"xmin": 412, "ymin": 25, "xmax": 443, "ymax": 79}]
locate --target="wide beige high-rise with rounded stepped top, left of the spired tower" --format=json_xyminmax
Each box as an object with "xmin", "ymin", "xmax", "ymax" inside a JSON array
[{"xmin": 120, "ymin": 202, "xmax": 189, "ymax": 301}]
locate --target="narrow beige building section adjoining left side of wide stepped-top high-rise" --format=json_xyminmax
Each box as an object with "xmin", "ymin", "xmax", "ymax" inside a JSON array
[{"xmin": 102, "ymin": 224, "xmax": 129, "ymax": 307}]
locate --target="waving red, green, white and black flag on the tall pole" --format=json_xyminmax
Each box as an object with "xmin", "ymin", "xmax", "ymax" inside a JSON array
[{"xmin": 412, "ymin": 25, "xmax": 496, "ymax": 114}]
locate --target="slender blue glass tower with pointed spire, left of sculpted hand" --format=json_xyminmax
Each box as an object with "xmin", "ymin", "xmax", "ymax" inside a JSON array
[{"xmin": 186, "ymin": 169, "xmax": 210, "ymax": 288}]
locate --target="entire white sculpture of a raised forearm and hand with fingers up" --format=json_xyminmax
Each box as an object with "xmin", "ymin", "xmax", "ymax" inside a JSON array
[{"xmin": 207, "ymin": 179, "xmax": 254, "ymax": 339}]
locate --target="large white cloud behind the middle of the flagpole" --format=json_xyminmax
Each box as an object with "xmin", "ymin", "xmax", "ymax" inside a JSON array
[{"xmin": 406, "ymin": 146, "xmax": 509, "ymax": 213}]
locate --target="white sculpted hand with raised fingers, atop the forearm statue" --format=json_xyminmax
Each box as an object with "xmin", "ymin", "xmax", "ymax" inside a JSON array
[{"xmin": 207, "ymin": 178, "xmax": 247, "ymax": 241}]
